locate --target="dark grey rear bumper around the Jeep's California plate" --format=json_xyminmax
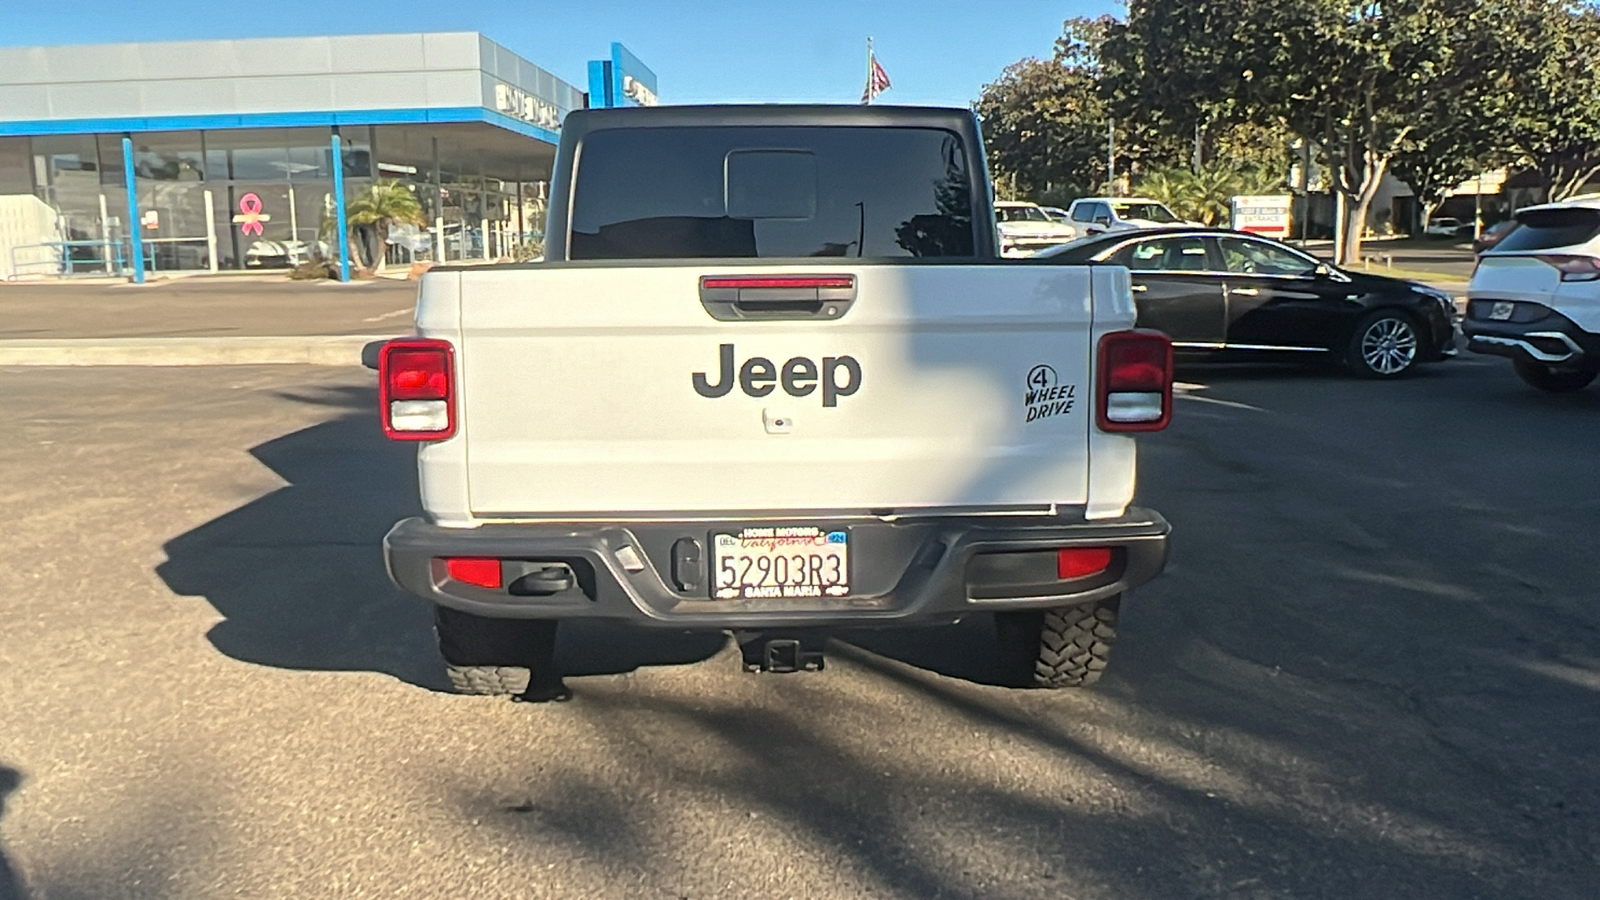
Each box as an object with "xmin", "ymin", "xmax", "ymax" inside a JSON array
[{"xmin": 384, "ymin": 509, "xmax": 1171, "ymax": 628}]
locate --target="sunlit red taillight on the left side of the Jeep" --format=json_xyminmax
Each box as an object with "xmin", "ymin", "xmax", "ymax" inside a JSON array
[{"xmin": 378, "ymin": 338, "xmax": 456, "ymax": 440}]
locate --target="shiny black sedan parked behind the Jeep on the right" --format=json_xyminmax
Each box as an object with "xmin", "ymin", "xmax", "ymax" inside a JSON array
[{"xmin": 1032, "ymin": 227, "xmax": 1456, "ymax": 378}]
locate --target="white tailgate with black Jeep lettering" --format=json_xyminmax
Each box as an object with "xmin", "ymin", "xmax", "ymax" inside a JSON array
[{"xmin": 444, "ymin": 263, "xmax": 1107, "ymax": 519}]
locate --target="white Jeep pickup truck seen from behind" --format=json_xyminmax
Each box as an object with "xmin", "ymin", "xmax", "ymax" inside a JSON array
[{"xmin": 378, "ymin": 106, "xmax": 1171, "ymax": 700}]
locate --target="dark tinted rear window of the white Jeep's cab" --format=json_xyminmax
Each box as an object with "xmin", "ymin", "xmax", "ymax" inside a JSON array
[{"xmin": 568, "ymin": 127, "xmax": 976, "ymax": 259}]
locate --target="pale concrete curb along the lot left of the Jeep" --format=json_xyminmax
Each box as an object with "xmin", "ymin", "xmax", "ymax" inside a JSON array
[{"xmin": 0, "ymin": 335, "xmax": 395, "ymax": 365}]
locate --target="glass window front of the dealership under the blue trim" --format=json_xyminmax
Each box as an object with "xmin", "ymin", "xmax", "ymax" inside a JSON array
[{"xmin": 10, "ymin": 125, "xmax": 549, "ymax": 272}]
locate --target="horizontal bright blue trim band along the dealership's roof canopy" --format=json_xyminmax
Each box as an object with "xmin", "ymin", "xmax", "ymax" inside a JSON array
[{"xmin": 0, "ymin": 106, "xmax": 560, "ymax": 144}]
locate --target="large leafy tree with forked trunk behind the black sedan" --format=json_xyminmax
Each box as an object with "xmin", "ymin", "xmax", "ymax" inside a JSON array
[{"xmin": 1102, "ymin": 0, "xmax": 1496, "ymax": 261}]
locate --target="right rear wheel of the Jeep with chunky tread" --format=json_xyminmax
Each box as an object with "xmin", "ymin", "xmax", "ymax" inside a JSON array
[{"xmin": 995, "ymin": 594, "xmax": 1122, "ymax": 689}]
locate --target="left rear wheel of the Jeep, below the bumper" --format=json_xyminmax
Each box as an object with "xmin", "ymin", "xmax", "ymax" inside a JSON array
[{"xmin": 434, "ymin": 607, "xmax": 555, "ymax": 697}]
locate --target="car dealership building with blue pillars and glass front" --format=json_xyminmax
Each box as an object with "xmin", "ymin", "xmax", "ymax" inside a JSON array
[{"xmin": 0, "ymin": 32, "xmax": 656, "ymax": 279}]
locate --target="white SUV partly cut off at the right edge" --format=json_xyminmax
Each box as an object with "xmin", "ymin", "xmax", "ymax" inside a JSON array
[{"xmin": 1462, "ymin": 194, "xmax": 1600, "ymax": 392}]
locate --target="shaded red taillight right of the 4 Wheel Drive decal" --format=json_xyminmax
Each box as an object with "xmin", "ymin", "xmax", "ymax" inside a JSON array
[{"xmin": 1094, "ymin": 330, "xmax": 1173, "ymax": 432}]
